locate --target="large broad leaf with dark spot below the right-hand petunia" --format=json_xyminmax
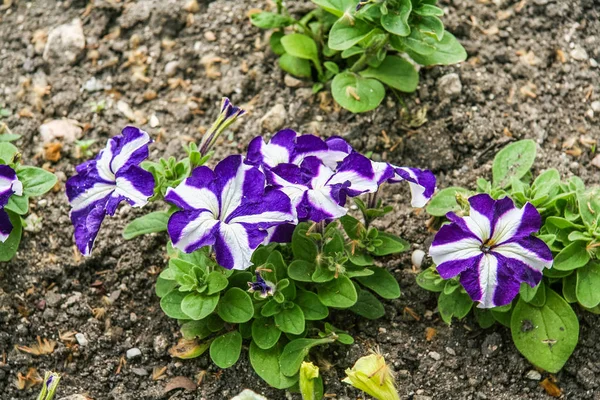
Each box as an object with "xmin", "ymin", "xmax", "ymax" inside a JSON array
[{"xmin": 510, "ymin": 289, "xmax": 579, "ymax": 374}]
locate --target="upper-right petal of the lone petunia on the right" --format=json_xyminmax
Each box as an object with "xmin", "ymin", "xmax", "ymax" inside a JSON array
[{"xmin": 492, "ymin": 202, "xmax": 542, "ymax": 245}]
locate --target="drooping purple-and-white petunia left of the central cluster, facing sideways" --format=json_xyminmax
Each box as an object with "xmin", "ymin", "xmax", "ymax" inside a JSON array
[{"xmin": 66, "ymin": 126, "xmax": 154, "ymax": 256}]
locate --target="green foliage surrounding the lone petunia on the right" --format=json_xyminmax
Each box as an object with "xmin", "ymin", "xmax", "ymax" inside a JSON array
[{"xmin": 424, "ymin": 140, "xmax": 600, "ymax": 373}]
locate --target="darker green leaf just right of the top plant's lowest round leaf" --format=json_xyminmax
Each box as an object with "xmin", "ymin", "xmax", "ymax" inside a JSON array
[{"xmin": 360, "ymin": 56, "xmax": 419, "ymax": 93}]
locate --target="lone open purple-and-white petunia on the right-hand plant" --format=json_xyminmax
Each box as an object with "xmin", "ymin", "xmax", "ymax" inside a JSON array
[{"xmin": 429, "ymin": 194, "xmax": 552, "ymax": 308}]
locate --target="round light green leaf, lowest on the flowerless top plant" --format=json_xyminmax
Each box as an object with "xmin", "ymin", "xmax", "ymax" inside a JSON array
[{"xmin": 331, "ymin": 72, "xmax": 385, "ymax": 113}]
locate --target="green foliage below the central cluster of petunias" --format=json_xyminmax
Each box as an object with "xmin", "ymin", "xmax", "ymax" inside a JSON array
[{"xmin": 156, "ymin": 203, "xmax": 408, "ymax": 389}]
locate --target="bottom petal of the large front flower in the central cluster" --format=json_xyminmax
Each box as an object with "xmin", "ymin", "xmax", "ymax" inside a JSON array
[{"xmin": 215, "ymin": 220, "xmax": 267, "ymax": 270}]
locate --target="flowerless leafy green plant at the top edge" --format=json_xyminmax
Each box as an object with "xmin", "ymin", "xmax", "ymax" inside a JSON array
[{"xmin": 250, "ymin": 0, "xmax": 467, "ymax": 113}]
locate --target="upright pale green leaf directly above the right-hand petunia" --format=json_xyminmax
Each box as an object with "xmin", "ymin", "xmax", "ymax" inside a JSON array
[{"xmin": 492, "ymin": 139, "xmax": 536, "ymax": 188}]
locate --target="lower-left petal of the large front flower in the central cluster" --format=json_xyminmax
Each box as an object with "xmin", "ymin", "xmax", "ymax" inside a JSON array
[{"xmin": 167, "ymin": 210, "xmax": 220, "ymax": 253}]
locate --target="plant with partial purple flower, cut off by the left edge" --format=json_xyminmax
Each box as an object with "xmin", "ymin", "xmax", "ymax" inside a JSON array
[{"xmin": 0, "ymin": 142, "xmax": 57, "ymax": 261}]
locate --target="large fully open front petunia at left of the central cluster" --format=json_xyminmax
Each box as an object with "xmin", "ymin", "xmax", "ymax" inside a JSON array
[{"xmin": 165, "ymin": 155, "xmax": 297, "ymax": 269}]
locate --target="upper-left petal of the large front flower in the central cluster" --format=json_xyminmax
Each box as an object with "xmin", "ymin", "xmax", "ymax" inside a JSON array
[{"xmin": 165, "ymin": 167, "xmax": 219, "ymax": 216}]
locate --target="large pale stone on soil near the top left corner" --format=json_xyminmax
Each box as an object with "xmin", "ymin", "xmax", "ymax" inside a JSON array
[{"xmin": 43, "ymin": 18, "xmax": 85, "ymax": 65}]
